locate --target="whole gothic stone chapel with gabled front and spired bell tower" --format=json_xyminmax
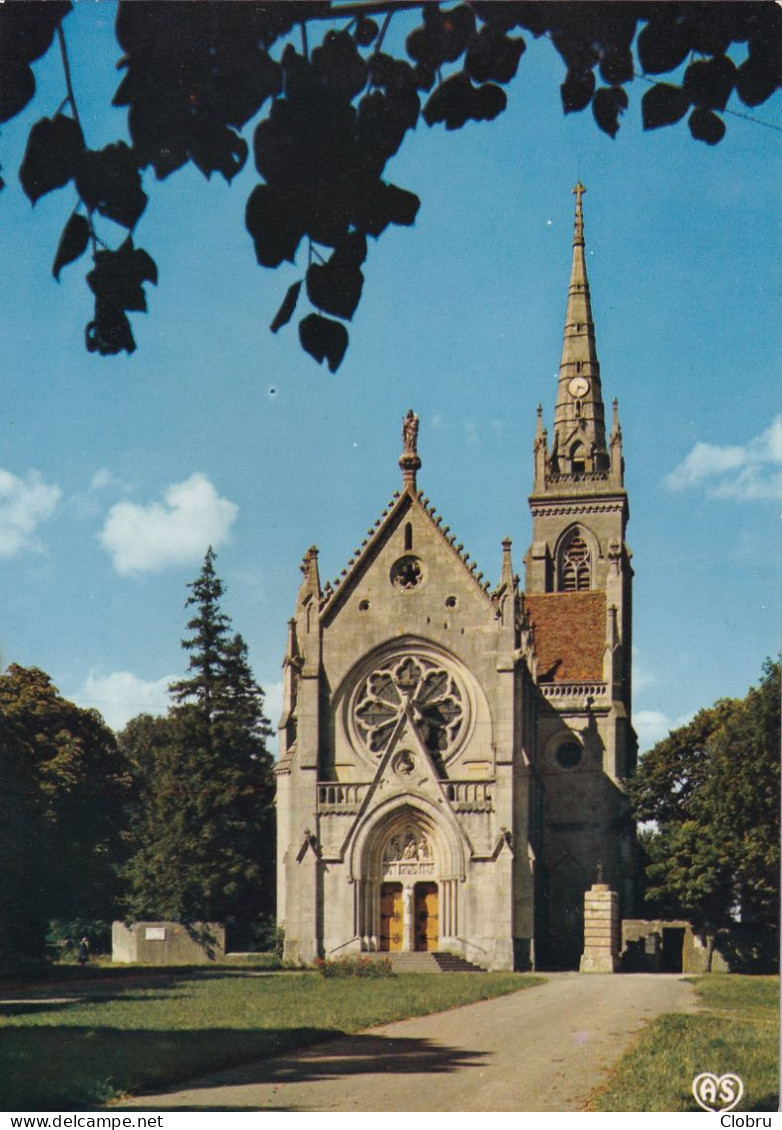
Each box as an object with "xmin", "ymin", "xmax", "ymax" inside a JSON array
[{"xmin": 277, "ymin": 183, "xmax": 636, "ymax": 970}]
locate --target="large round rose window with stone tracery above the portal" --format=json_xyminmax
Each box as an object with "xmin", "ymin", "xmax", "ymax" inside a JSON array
[{"xmin": 353, "ymin": 655, "xmax": 467, "ymax": 756}]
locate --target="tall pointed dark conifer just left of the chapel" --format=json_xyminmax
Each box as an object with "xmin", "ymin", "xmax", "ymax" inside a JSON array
[{"xmin": 120, "ymin": 549, "xmax": 275, "ymax": 940}]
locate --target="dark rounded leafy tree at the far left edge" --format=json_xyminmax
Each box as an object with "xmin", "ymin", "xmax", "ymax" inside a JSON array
[{"xmin": 0, "ymin": 664, "xmax": 129, "ymax": 956}]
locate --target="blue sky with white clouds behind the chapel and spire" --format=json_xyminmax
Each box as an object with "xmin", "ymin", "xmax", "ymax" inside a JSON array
[{"xmin": 0, "ymin": 11, "xmax": 782, "ymax": 748}]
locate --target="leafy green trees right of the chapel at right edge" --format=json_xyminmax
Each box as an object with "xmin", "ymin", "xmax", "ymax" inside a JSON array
[{"xmin": 631, "ymin": 661, "xmax": 780, "ymax": 953}]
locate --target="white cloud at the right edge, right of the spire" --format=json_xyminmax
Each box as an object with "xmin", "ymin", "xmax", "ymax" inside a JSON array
[{"xmin": 666, "ymin": 416, "xmax": 782, "ymax": 502}]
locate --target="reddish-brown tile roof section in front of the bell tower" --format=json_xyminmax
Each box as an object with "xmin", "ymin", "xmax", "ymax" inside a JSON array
[{"xmin": 524, "ymin": 590, "xmax": 606, "ymax": 683}]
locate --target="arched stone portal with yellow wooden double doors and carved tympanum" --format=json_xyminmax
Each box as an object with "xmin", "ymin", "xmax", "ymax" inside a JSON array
[{"xmin": 353, "ymin": 799, "xmax": 463, "ymax": 953}]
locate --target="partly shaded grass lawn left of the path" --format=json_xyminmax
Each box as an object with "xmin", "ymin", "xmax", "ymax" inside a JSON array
[{"xmin": 0, "ymin": 967, "xmax": 545, "ymax": 1111}]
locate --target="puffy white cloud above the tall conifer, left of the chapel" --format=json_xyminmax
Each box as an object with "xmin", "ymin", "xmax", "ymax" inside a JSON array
[{"xmin": 98, "ymin": 473, "xmax": 238, "ymax": 574}]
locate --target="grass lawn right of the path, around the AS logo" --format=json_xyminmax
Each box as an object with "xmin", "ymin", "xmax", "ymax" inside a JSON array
[{"xmin": 589, "ymin": 973, "xmax": 780, "ymax": 1112}]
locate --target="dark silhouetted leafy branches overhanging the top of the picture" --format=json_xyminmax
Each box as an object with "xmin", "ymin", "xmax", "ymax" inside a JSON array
[{"xmin": 0, "ymin": 0, "xmax": 782, "ymax": 372}]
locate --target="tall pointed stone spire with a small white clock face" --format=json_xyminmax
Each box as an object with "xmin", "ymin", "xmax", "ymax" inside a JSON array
[{"xmin": 551, "ymin": 181, "xmax": 609, "ymax": 473}]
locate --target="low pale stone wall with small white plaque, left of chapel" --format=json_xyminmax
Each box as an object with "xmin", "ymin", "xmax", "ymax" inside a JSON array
[{"xmin": 112, "ymin": 922, "xmax": 225, "ymax": 965}]
